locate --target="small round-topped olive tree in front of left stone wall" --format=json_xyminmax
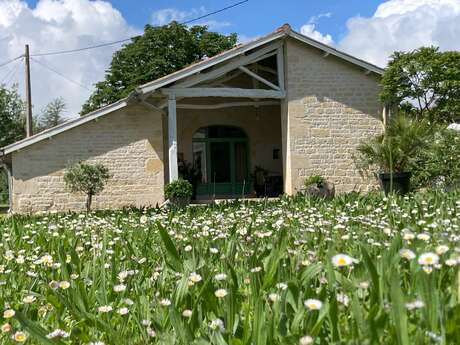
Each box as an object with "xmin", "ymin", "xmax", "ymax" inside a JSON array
[{"xmin": 64, "ymin": 162, "xmax": 110, "ymax": 212}]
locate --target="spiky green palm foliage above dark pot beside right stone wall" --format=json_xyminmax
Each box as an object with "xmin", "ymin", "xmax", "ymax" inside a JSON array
[{"xmin": 355, "ymin": 115, "xmax": 429, "ymax": 172}]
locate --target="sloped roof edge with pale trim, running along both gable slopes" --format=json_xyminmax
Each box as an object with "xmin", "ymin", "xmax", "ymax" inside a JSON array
[{"xmin": 0, "ymin": 24, "xmax": 383, "ymax": 157}]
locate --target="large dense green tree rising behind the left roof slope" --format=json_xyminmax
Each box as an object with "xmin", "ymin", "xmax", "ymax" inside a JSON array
[{"xmin": 81, "ymin": 22, "xmax": 237, "ymax": 115}]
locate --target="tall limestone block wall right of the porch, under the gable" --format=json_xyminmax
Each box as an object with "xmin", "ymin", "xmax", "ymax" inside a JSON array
[{"xmin": 285, "ymin": 40, "xmax": 383, "ymax": 193}]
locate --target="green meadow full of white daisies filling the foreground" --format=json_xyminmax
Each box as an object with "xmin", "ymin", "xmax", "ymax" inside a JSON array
[{"xmin": 0, "ymin": 192, "xmax": 460, "ymax": 345}]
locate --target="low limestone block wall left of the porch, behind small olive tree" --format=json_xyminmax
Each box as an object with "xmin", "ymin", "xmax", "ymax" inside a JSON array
[{"xmin": 12, "ymin": 105, "xmax": 164, "ymax": 213}]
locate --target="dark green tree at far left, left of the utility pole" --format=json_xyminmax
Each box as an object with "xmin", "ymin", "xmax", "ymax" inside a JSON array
[{"xmin": 0, "ymin": 85, "xmax": 26, "ymax": 147}]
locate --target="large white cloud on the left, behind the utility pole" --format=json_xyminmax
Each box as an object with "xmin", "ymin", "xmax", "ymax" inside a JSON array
[{"xmin": 0, "ymin": 0, "xmax": 139, "ymax": 116}]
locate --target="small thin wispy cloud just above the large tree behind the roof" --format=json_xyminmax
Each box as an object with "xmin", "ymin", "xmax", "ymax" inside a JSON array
[{"xmin": 152, "ymin": 6, "xmax": 231, "ymax": 30}]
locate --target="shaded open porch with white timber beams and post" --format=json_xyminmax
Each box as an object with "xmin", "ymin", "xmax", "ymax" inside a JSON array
[{"xmin": 137, "ymin": 40, "xmax": 287, "ymax": 200}]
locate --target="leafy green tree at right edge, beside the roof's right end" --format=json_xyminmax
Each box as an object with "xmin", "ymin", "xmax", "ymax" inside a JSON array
[{"xmin": 381, "ymin": 47, "xmax": 460, "ymax": 122}]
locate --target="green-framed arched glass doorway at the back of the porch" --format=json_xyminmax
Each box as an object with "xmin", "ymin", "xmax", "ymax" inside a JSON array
[{"xmin": 192, "ymin": 126, "xmax": 250, "ymax": 198}]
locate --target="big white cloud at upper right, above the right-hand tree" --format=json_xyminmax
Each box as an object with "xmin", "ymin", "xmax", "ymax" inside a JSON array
[{"xmin": 338, "ymin": 0, "xmax": 460, "ymax": 66}]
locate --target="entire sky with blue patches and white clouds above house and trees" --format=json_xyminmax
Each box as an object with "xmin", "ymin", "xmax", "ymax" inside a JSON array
[{"xmin": 0, "ymin": 0, "xmax": 460, "ymax": 117}]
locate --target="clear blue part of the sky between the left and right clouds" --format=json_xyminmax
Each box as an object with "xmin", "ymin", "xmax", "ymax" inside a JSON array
[{"xmin": 27, "ymin": 0, "xmax": 383, "ymax": 40}]
